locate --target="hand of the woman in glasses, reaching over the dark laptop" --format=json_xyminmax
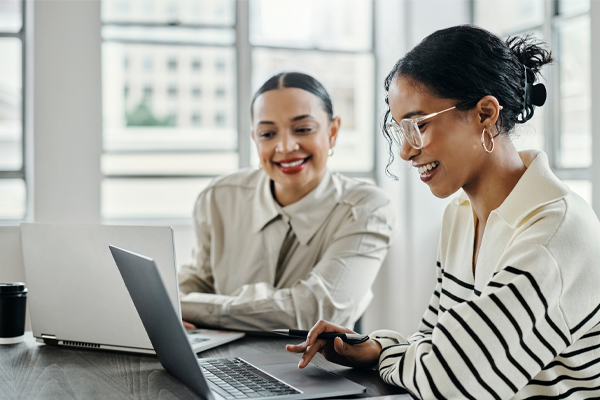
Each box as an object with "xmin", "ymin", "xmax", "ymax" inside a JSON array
[{"xmin": 285, "ymin": 320, "xmax": 381, "ymax": 368}]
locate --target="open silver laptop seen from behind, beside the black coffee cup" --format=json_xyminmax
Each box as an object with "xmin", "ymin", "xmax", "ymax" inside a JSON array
[{"xmin": 21, "ymin": 224, "xmax": 244, "ymax": 354}]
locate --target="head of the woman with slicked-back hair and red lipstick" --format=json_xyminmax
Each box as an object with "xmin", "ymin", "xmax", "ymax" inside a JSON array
[{"xmin": 251, "ymin": 73, "xmax": 340, "ymax": 205}]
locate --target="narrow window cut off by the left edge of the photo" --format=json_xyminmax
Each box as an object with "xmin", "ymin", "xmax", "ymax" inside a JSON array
[{"xmin": 0, "ymin": 0, "xmax": 27, "ymax": 220}]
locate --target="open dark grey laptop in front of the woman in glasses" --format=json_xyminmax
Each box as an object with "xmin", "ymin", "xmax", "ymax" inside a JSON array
[{"xmin": 110, "ymin": 246, "xmax": 366, "ymax": 400}]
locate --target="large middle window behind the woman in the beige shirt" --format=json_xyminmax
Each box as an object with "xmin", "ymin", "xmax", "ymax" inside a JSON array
[{"xmin": 101, "ymin": 0, "xmax": 376, "ymax": 220}]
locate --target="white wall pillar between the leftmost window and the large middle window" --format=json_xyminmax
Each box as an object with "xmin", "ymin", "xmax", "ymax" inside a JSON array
[{"xmin": 28, "ymin": 0, "xmax": 102, "ymax": 223}]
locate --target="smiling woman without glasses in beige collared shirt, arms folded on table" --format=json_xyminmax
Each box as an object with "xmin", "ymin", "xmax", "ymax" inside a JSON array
[{"xmin": 179, "ymin": 72, "xmax": 394, "ymax": 331}]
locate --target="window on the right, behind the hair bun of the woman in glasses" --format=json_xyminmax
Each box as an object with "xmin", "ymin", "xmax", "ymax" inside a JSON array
[{"xmin": 474, "ymin": 0, "xmax": 592, "ymax": 203}]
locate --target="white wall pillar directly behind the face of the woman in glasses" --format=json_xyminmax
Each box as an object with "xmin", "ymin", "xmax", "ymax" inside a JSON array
[{"xmin": 363, "ymin": 0, "xmax": 470, "ymax": 334}]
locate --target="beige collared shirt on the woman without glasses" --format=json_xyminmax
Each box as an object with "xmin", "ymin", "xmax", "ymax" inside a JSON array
[{"xmin": 179, "ymin": 169, "xmax": 394, "ymax": 330}]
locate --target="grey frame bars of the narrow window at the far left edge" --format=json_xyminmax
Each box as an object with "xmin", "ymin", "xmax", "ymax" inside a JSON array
[{"xmin": 0, "ymin": 0, "xmax": 30, "ymax": 222}]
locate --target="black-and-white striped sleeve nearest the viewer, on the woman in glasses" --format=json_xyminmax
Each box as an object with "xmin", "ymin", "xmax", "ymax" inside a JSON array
[{"xmin": 372, "ymin": 245, "xmax": 572, "ymax": 399}]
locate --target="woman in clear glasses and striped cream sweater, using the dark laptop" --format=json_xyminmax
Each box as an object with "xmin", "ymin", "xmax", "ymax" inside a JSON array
[{"xmin": 288, "ymin": 26, "xmax": 600, "ymax": 399}]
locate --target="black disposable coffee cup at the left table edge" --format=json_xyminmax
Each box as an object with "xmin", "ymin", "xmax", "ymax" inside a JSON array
[{"xmin": 0, "ymin": 282, "xmax": 27, "ymax": 344}]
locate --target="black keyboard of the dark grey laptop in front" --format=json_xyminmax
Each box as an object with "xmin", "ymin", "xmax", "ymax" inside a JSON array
[{"xmin": 198, "ymin": 358, "xmax": 300, "ymax": 399}]
